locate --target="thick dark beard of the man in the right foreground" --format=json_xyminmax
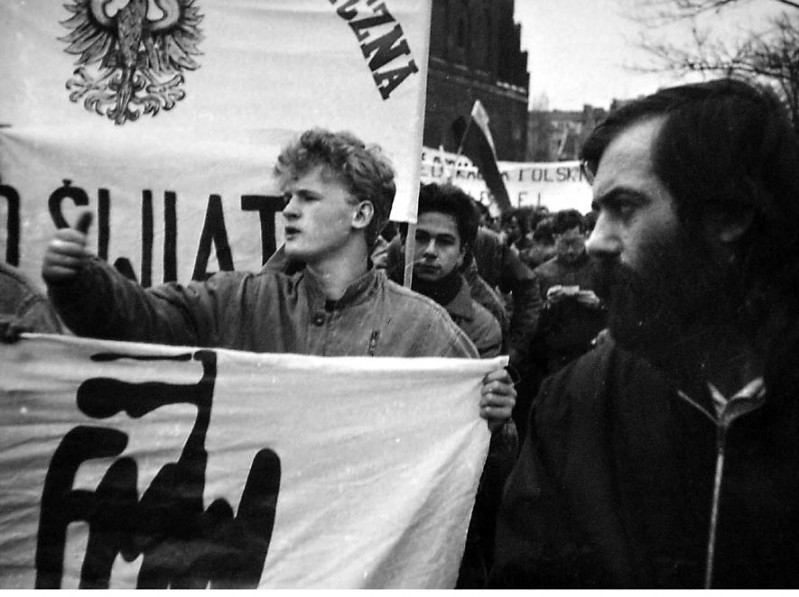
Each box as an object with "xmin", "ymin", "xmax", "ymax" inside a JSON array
[{"xmin": 598, "ymin": 229, "xmax": 744, "ymax": 366}]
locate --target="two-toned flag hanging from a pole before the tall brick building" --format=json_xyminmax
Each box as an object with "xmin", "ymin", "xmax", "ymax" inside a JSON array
[{"xmin": 451, "ymin": 100, "xmax": 511, "ymax": 211}]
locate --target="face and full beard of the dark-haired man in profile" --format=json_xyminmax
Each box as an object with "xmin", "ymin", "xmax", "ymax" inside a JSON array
[{"xmin": 587, "ymin": 118, "xmax": 726, "ymax": 356}]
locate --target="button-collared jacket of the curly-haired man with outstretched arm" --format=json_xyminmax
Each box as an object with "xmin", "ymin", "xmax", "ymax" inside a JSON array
[{"xmin": 50, "ymin": 260, "xmax": 478, "ymax": 358}]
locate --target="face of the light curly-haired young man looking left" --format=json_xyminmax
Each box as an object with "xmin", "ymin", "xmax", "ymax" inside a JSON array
[{"xmin": 281, "ymin": 165, "xmax": 358, "ymax": 265}]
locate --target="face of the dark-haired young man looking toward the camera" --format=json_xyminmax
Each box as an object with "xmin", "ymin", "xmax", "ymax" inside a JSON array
[{"xmin": 413, "ymin": 211, "xmax": 465, "ymax": 282}]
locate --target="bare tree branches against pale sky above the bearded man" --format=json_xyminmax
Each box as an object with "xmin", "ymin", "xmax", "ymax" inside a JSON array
[{"xmin": 634, "ymin": 0, "xmax": 799, "ymax": 132}]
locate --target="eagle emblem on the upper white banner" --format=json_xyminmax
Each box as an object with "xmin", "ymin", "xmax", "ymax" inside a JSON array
[{"xmin": 60, "ymin": 0, "xmax": 204, "ymax": 125}]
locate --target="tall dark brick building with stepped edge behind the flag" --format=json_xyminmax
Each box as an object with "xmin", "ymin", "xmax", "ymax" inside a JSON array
[{"xmin": 424, "ymin": 0, "xmax": 530, "ymax": 161}]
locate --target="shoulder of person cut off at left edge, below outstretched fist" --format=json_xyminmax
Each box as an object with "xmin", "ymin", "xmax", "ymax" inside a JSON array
[{"xmin": 0, "ymin": 261, "xmax": 62, "ymax": 341}]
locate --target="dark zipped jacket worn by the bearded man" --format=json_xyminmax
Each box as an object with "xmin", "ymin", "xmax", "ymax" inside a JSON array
[{"xmin": 492, "ymin": 342, "xmax": 799, "ymax": 588}]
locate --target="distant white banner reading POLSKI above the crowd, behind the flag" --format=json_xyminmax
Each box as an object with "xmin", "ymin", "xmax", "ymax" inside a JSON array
[{"xmin": 421, "ymin": 147, "xmax": 591, "ymax": 215}]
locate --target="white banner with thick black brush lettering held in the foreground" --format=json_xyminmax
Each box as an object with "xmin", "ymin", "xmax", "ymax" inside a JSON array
[{"xmin": 0, "ymin": 335, "xmax": 504, "ymax": 589}]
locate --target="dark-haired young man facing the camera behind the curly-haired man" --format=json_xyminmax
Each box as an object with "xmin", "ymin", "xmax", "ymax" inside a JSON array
[{"xmin": 389, "ymin": 183, "xmax": 502, "ymax": 358}]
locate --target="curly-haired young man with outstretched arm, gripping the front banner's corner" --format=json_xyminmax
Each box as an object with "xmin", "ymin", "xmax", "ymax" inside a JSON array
[{"xmin": 42, "ymin": 129, "xmax": 515, "ymax": 428}]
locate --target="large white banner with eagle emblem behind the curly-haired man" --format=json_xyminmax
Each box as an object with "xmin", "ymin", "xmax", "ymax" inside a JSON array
[{"xmin": 0, "ymin": 0, "xmax": 431, "ymax": 286}]
